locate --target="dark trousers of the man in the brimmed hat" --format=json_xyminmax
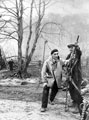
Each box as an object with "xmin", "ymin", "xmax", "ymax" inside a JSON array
[{"xmin": 69, "ymin": 81, "xmax": 83, "ymax": 114}]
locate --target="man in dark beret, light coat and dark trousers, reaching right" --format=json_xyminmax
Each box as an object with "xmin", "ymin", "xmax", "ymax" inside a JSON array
[{"xmin": 41, "ymin": 49, "xmax": 69, "ymax": 112}]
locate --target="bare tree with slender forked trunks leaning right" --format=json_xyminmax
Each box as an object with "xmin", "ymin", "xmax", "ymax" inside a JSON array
[{"xmin": 24, "ymin": 0, "xmax": 45, "ymax": 71}]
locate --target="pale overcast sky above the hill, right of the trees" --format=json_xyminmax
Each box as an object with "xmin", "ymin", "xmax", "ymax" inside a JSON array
[{"xmin": 47, "ymin": 0, "xmax": 89, "ymax": 15}]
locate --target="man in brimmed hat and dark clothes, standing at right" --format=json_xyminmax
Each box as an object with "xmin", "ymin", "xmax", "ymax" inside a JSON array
[{"xmin": 67, "ymin": 44, "xmax": 83, "ymax": 113}]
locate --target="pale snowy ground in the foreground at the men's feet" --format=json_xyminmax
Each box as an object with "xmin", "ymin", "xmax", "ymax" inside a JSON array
[{"xmin": 0, "ymin": 100, "xmax": 79, "ymax": 120}]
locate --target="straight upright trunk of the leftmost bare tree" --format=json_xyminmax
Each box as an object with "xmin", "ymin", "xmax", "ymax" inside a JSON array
[{"xmin": 17, "ymin": 0, "xmax": 23, "ymax": 71}]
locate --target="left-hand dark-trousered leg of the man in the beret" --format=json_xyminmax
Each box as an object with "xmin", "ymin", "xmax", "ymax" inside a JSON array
[{"xmin": 42, "ymin": 86, "xmax": 49, "ymax": 108}]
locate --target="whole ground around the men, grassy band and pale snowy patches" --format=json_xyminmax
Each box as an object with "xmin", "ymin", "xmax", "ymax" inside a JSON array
[{"xmin": 0, "ymin": 69, "xmax": 88, "ymax": 120}]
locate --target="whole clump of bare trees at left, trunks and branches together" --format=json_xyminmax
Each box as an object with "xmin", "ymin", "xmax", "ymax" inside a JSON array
[{"xmin": 0, "ymin": 0, "xmax": 50, "ymax": 72}]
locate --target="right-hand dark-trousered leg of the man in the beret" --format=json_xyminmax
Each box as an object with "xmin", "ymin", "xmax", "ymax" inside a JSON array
[{"xmin": 50, "ymin": 81, "xmax": 58, "ymax": 102}]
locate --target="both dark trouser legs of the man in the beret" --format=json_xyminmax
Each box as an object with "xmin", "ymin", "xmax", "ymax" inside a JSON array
[{"xmin": 42, "ymin": 81, "xmax": 58, "ymax": 108}]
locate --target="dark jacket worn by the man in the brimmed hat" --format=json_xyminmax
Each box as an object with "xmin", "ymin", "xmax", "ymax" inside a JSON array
[{"xmin": 66, "ymin": 48, "xmax": 82, "ymax": 89}]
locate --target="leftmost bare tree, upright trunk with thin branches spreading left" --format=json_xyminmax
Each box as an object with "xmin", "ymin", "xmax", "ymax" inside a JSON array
[{"xmin": 0, "ymin": 0, "xmax": 23, "ymax": 70}]
